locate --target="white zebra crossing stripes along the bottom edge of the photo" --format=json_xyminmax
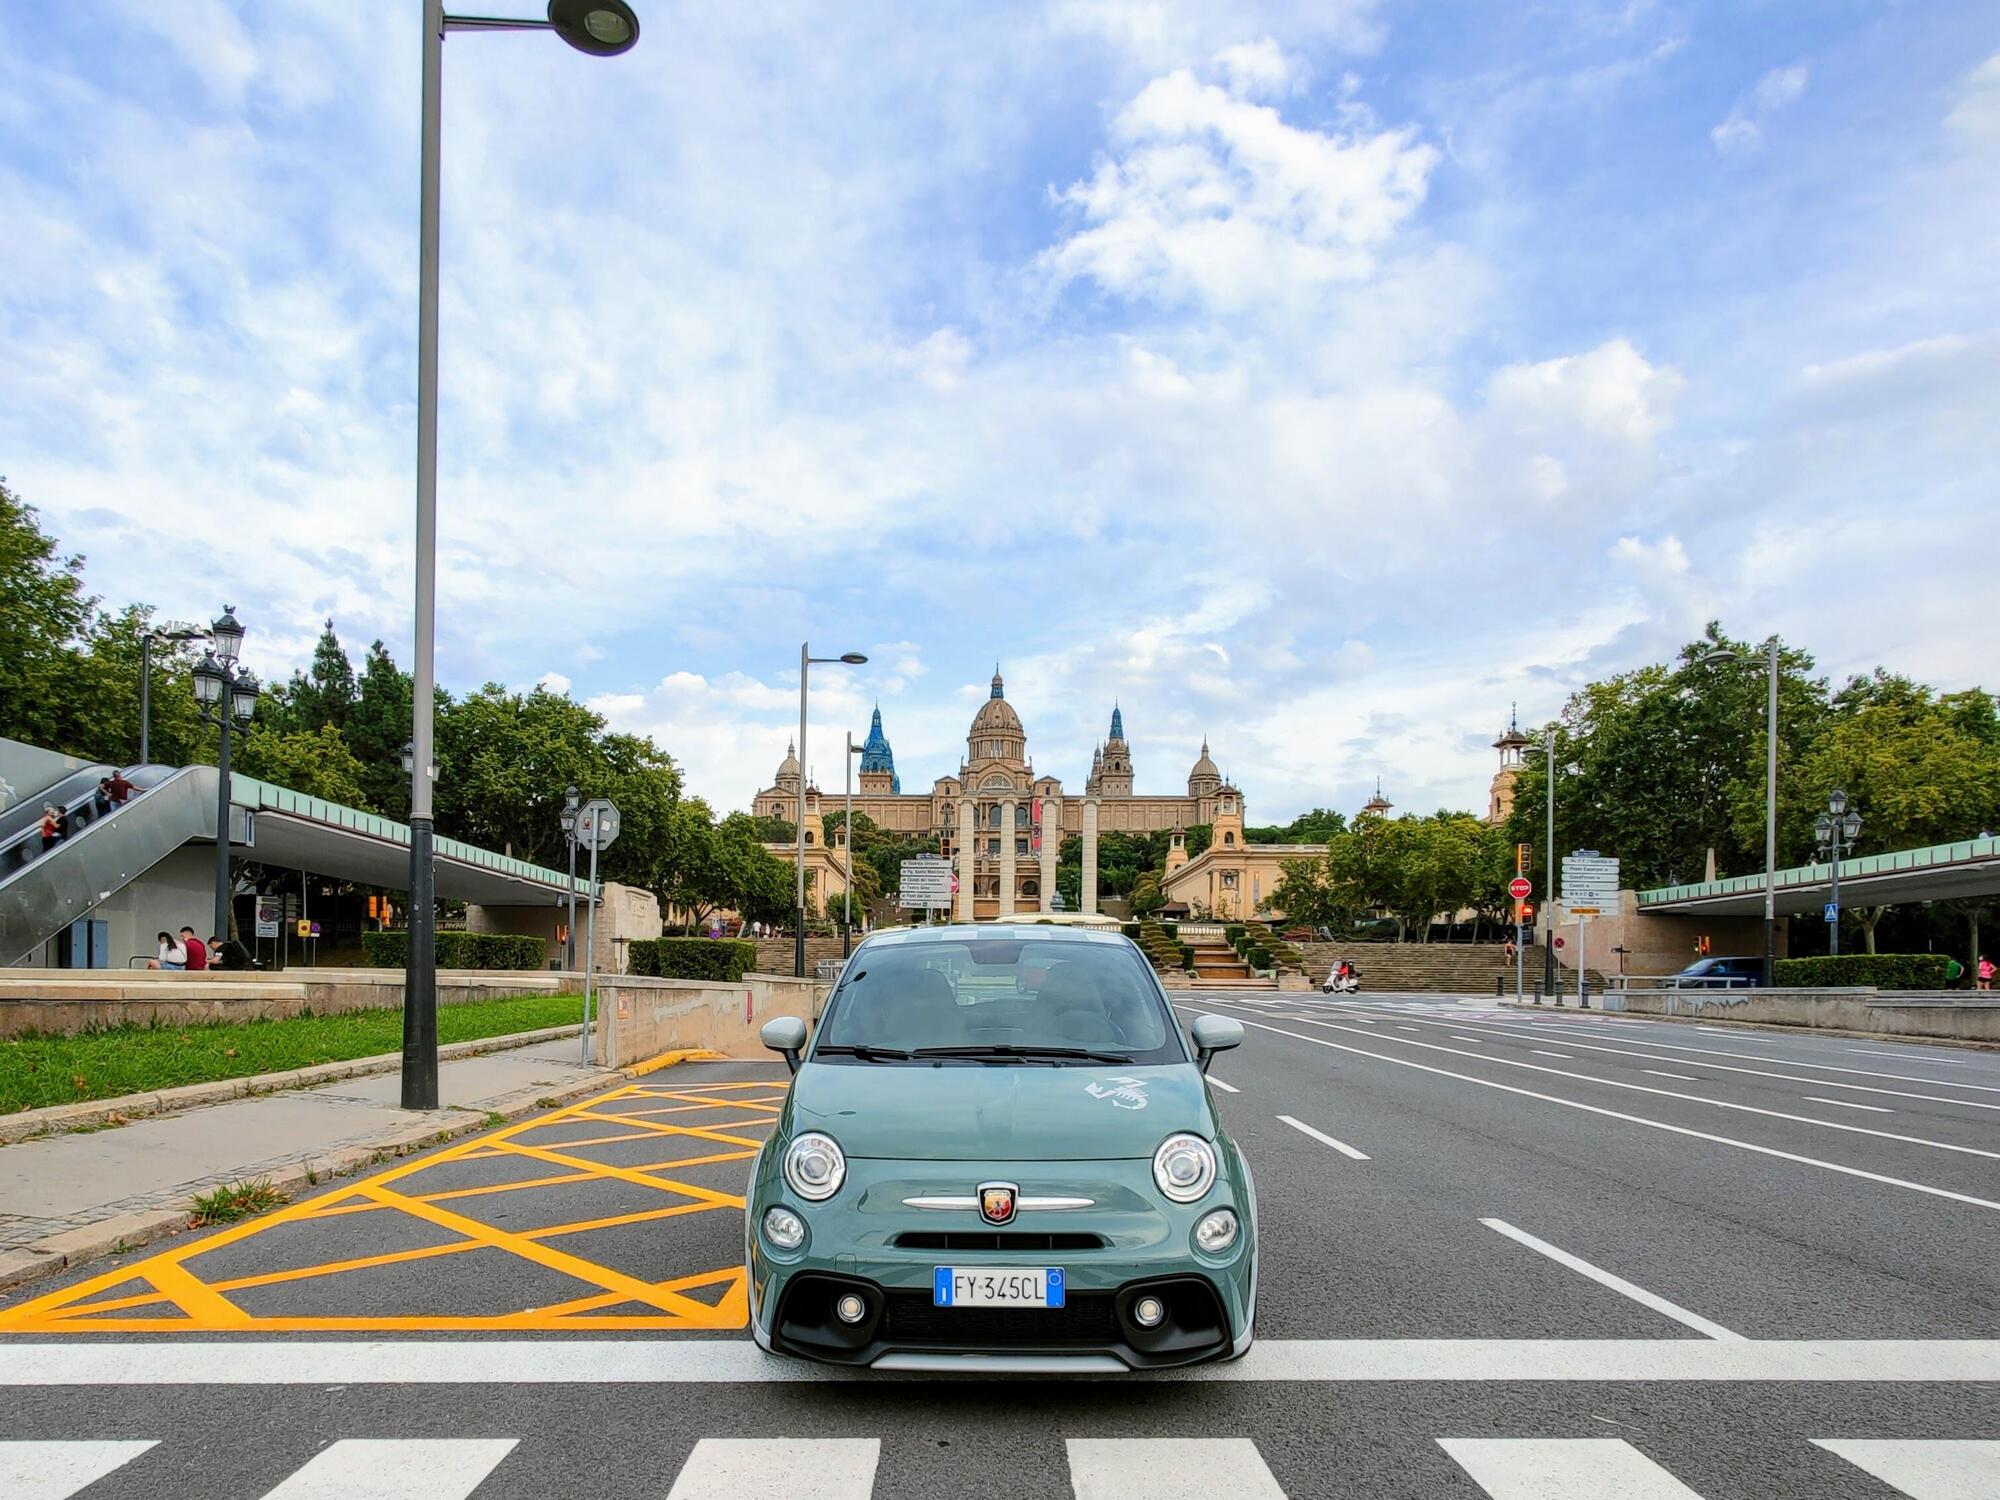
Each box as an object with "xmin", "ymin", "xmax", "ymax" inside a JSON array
[{"xmin": 0, "ymin": 1438, "xmax": 2000, "ymax": 1500}]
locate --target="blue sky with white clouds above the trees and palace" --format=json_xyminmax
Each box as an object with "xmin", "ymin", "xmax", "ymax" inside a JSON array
[{"xmin": 0, "ymin": 0, "xmax": 2000, "ymax": 820}]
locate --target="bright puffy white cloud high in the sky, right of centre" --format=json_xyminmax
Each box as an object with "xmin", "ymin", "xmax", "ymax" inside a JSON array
[{"xmin": 1042, "ymin": 70, "xmax": 1438, "ymax": 308}]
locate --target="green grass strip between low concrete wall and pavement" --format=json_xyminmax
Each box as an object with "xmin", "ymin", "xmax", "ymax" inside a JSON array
[{"xmin": 0, "ymin": 994, "xmax": 584, "ymax": 1114}]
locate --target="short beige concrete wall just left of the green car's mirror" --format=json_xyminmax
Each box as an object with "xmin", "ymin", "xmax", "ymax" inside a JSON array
[{"xmin": 592, "ymin": 974, "xmax": 830, "ymax": 1068}]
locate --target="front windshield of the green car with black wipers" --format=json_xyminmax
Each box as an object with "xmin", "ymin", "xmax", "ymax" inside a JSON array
[{"xmin": 812, "ymin": 936, "xmax": 1188, "ymax": 1066}]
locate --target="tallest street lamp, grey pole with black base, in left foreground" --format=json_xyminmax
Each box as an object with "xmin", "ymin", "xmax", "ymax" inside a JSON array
[{"xmin": 402, "ymin": 0, "xmax": 638, "ymax": 1110}]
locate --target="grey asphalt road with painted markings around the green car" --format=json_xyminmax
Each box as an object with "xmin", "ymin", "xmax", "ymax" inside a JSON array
[{"xmin": 0, "ymin": 996, "xmax": 2000, "ymax": 1500}]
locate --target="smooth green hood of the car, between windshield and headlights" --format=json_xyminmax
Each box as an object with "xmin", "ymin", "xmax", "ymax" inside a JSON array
[{"xmin": 790, "ymin": 1062, "xmax": 1214, "ymax": 1162}]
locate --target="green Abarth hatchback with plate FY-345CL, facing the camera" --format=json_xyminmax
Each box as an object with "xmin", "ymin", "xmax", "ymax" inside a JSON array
[{"xmin": 744, "ymin": 924, "xmax": 1256, "ymax": 1372}]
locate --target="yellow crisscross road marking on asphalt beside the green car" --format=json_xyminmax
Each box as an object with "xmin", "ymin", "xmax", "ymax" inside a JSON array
[{"xmin": 0, "ymin": 1078, "xmax": 784, "ymax": 1336}]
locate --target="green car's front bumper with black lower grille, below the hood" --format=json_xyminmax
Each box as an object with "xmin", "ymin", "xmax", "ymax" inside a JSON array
[{"xmin": 744, "ymin": 1150, "xmax": 1256, "ymax": 1372}]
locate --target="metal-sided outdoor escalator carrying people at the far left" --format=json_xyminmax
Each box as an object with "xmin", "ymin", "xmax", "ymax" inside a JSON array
[{"xmin": 0, "ymin": 766, "xmax": 216, "ymax": 968}]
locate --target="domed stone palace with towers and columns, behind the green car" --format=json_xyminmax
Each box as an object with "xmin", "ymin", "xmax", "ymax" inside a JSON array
[{"xmin": 750, "ymin": 666, "xmax": 1242, "ymax": 920}]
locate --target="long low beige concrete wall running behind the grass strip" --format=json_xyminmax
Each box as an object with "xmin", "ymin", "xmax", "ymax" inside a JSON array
[{"xmin": 0, "ymin": 968, "xmax": 582, "ymax": 1038}]
